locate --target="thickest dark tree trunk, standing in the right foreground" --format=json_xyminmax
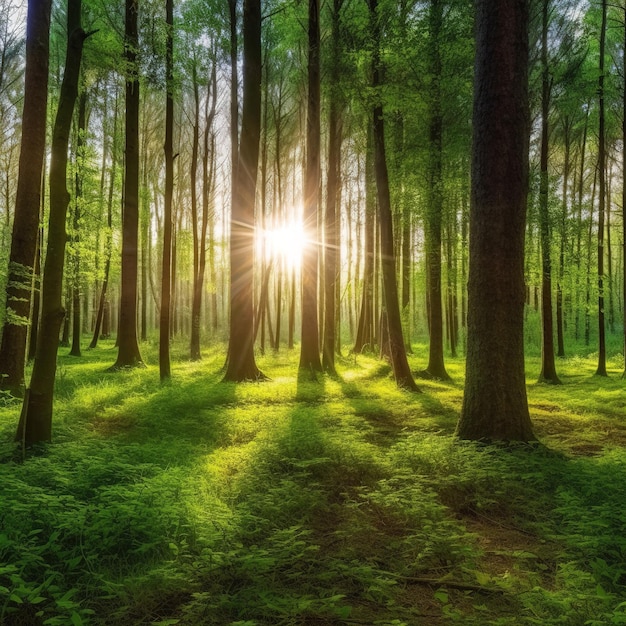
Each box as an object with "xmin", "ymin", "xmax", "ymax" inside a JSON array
[{"xmin": 457, "ymin": 0, "xmax": 534, "ymax": 441}]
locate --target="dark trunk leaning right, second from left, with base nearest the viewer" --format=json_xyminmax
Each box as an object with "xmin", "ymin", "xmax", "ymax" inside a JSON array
[{"xmin": 16, "ymin": 0, "xmax": 87, "ymax": 446}]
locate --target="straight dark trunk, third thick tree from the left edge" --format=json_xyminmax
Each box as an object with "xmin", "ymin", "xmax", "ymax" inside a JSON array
[{"xmin": 112, "ymin": 0, "xmax": 143, "ymax": 369}]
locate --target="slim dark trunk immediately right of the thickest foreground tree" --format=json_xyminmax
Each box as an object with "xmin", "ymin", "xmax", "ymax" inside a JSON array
[{"xmin": 539, "ymin": 0, "xmax": 561, "ymax": 384}]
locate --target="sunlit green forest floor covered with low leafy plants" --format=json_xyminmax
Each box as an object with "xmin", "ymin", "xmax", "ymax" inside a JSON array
[{"xmin": 0, "ymin": 343, "xmax": 626, "ymax": 626}]
